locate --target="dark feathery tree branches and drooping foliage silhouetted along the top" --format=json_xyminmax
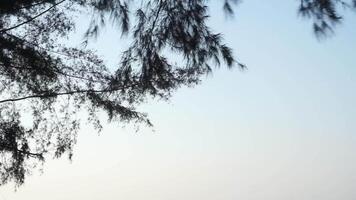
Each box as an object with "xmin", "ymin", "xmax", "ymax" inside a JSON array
[{"xmin": 0, "ymin": 0, "xmax": 356, "ymax": 186}]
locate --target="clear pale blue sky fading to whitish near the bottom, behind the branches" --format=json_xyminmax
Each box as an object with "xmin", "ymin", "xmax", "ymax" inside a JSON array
[{"xmin": 0, "ymin": 0, "xmax": 356, "ymax": 200}]
